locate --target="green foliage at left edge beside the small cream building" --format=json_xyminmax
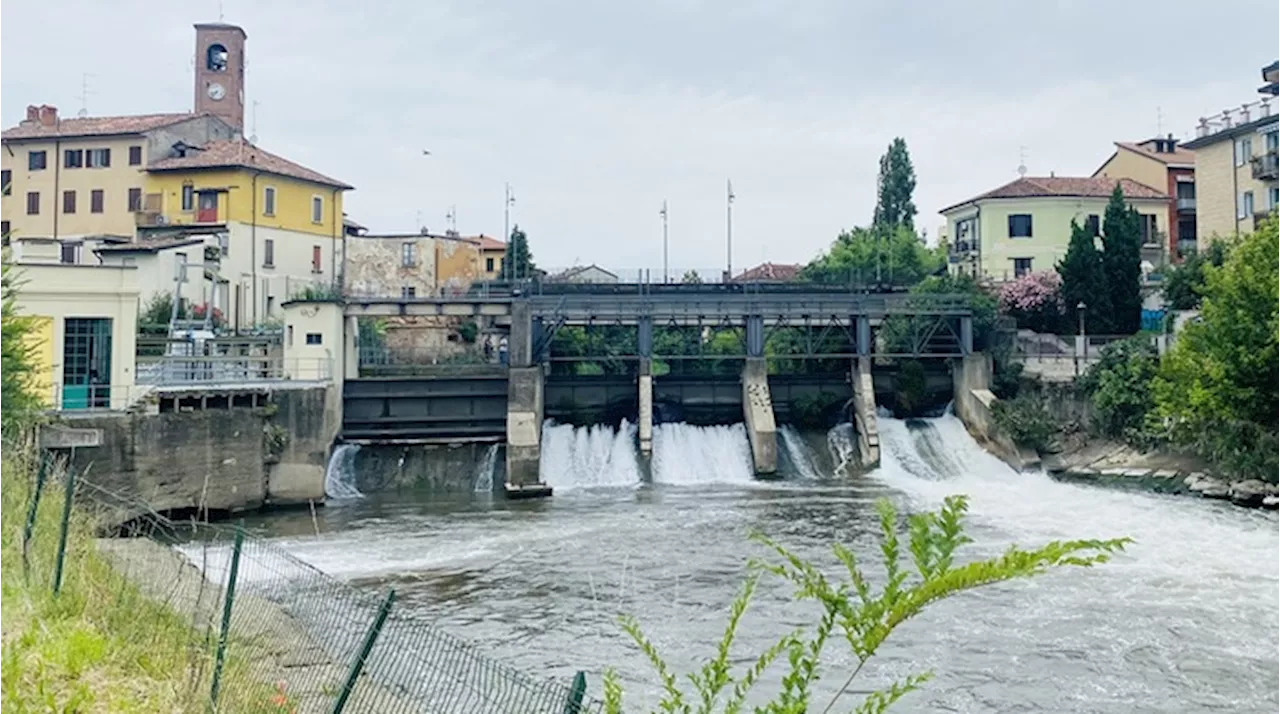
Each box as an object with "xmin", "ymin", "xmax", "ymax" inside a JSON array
[{"xmin": 0, "ymin": 234, "xmax": 44, "ymax": 443}]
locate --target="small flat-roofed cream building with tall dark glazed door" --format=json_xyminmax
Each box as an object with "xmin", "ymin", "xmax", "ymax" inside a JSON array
[{"xmin": 18, "ymin": 264, "xmax": 138, "ymax": 409}]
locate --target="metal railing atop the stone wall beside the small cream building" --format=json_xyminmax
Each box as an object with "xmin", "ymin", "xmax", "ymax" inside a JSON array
[{"xmin": 136, "ymin": 356, "xmax": 333, "ymax": 385}]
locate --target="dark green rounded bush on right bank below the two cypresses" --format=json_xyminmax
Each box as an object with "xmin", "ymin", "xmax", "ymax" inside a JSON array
[{"xmin": 1080, "ymin": 335, "xmax": 1160, "ymax": 445}]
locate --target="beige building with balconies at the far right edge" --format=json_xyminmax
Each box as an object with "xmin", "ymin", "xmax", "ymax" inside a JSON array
[{"xmin": 1184, "ymin": 100, "xmax": 1280, "ymax": 250}]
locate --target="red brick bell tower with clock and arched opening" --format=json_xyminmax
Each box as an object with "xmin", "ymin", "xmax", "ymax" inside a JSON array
[{"xmin": 195, "ymin": 23, "xmax": 248, "ymax": 133}]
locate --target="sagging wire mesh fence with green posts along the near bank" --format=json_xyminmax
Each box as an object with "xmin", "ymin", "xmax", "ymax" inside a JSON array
[{"xmin": 23, "ymin": 452, "xmax": 603, "ymax": 714}]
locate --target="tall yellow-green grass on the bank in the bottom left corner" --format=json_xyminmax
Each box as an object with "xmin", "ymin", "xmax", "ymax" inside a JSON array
[{"xmin": 0, "ymin": 449, "xmax": 289, "ymax": 714}]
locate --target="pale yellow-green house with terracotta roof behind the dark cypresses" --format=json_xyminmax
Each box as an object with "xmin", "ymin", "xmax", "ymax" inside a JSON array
[{"xmin": 941, "ymin": 177, "xmax": 1169, "ymax": 282}]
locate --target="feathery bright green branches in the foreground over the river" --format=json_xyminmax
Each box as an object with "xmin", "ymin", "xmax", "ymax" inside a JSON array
[{"xmin": 604, "ymin": 495, "xmax": 1129, "ymax": 714}]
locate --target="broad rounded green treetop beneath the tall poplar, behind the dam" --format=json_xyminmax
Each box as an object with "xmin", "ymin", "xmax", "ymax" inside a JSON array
[{"xmin": 800, "ymin": 226, "xmax": 946, "ymax": 285}]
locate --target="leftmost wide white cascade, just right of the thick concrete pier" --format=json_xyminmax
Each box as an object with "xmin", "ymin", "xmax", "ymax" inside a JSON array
[{"xmin": 539, "ymin": 420, "xmax": 640, "ymax": 491}]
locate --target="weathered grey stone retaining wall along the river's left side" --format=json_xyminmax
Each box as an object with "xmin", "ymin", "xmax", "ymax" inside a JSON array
[{"xmin": 65, "ymin": 388, "xmax": 339, "ymax": 522}]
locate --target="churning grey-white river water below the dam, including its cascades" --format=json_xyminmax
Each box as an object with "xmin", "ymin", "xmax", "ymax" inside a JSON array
[{"xmin": 259, "ymin": 416, "xmax": 1280, "ymax": 714}]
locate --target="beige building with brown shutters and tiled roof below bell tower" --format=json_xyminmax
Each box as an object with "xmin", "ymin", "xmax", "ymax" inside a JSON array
[{"xmin": 0, "ymin": 106, "xmax": 233, "ymax": 252}]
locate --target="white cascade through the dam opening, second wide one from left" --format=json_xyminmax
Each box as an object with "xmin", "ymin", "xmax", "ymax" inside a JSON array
[{"xmin": 652, "ymin": 424, "xmax": 755, "ymax": 485}]
